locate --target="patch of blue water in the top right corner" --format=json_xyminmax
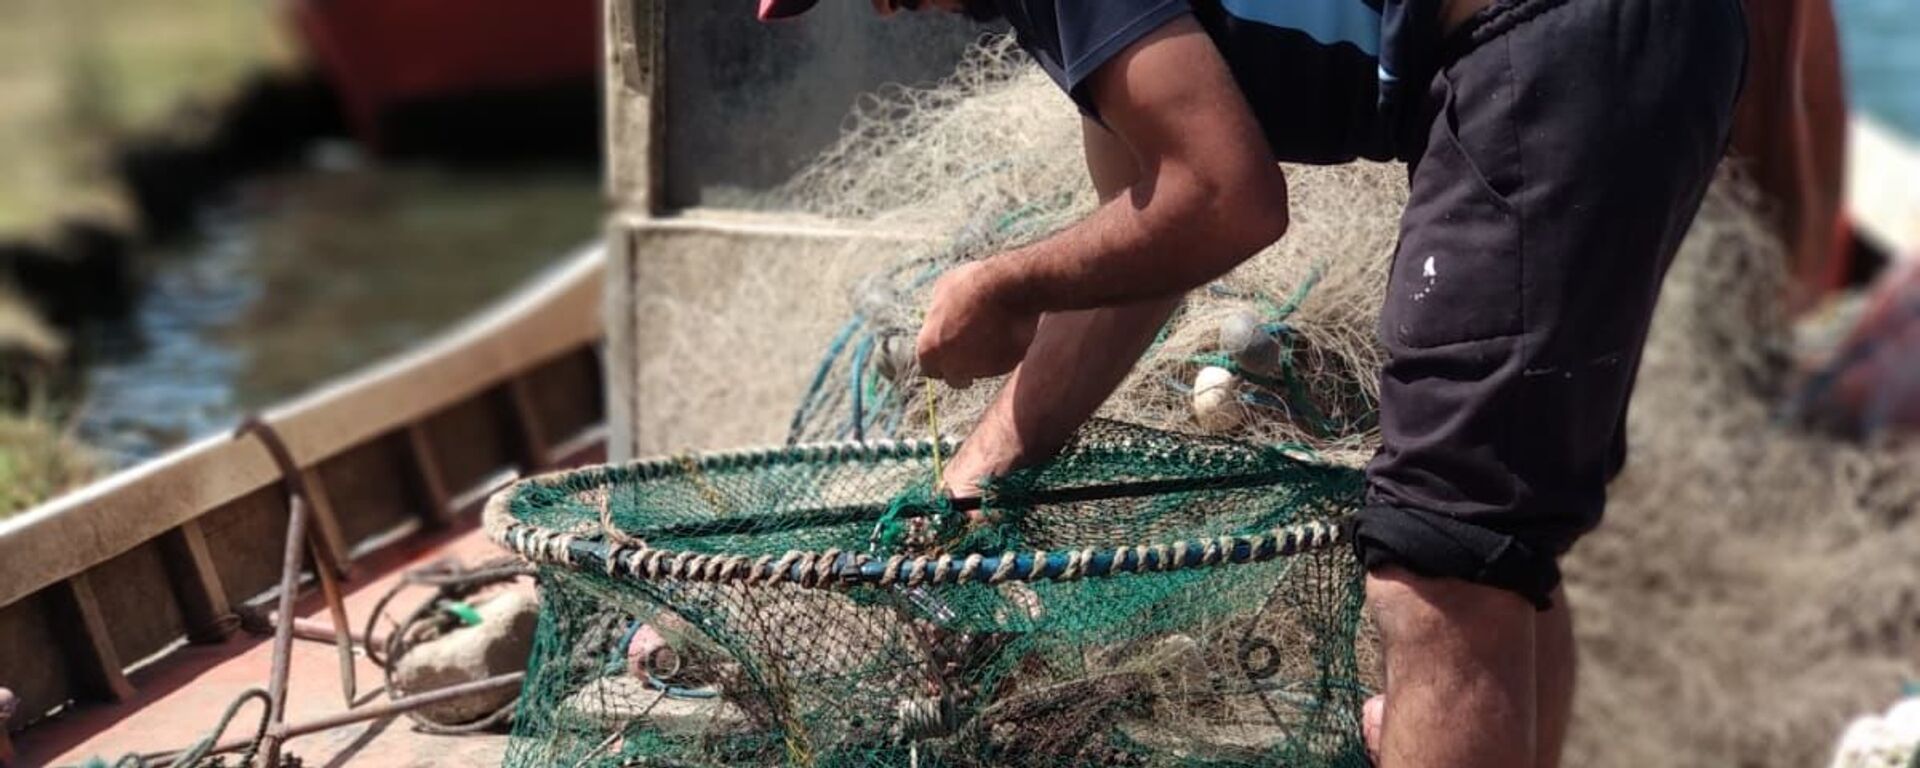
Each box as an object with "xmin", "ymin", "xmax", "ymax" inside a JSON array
[{"xmin": 1827, "ymin": 0, "xmax": 1920, "ymax": 140}]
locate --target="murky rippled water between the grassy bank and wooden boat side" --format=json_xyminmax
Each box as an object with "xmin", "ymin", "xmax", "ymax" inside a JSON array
[{"xmin": 77, "ymin": 161, "xmax": 601, "ymax": 467}]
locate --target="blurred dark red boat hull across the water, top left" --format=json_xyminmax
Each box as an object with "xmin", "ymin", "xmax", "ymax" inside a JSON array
[{"xmin": 292, "ymin": 0, "xmax": 599, "ymax": 150}]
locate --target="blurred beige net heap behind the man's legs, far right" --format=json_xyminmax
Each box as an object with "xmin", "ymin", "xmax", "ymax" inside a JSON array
[{"xmin": 1565, "ymin": 175, "xmax": 1920, "ymax": 768}]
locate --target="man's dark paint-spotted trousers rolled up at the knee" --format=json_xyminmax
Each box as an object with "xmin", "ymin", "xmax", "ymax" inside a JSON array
[{"xmin": 1356, "ymin": 0, "xmax": 1745, "ymax": 607}]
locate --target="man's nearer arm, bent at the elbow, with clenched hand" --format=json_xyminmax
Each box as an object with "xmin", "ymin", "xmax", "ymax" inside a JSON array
[{"xmin": 920, "ymin": 17, "xmax": 1286, "ymax": 389}]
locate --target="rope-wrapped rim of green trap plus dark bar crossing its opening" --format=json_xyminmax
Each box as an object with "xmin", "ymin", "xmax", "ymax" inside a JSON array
[{"xmin": 486, "ymin": 440, "xmax": 1352, "ymax": 588}]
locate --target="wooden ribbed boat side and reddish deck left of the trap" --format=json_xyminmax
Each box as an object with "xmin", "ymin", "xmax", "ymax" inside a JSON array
[{"xmin": 0, "ymin": 244, "xmax": 607, "ymax": 766}]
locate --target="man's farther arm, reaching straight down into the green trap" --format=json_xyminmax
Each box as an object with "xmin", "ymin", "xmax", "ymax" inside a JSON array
[{"xmin": 945, "ymin": 119, "xmax": 1179, "ymax": 495}]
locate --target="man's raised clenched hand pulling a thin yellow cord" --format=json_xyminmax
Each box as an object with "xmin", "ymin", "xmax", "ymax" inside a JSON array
[{"xmin": 918, "ymin": 261, "xmax": 1041, "ymax": 388}]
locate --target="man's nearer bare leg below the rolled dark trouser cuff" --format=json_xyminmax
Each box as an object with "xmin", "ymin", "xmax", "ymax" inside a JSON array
[{"xmin": 1367, "ymin": 568, "xmax": 1538, "ymax": 768}]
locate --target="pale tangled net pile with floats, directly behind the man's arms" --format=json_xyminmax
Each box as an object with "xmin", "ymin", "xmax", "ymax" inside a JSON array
[{"xmin": 781, "ymin": 38, "xmax": 1405, "ymax": 465}]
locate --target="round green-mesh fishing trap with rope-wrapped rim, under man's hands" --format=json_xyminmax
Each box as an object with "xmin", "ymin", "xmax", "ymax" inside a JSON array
[{"xmin": 488, "ymin": 422, "xmax": 1367, "ymax": 766}]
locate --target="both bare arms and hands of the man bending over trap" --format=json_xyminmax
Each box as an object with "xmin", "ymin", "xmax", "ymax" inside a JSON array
[{"xmin": 918, "ymin": 15, "xmax": 1286, "ymax": 495}]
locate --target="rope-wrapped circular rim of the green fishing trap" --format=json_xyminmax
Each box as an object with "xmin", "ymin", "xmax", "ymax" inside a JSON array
[{"xmin": 484, "ymin": 440, "xmax": 1352, "ymax": 588}]
